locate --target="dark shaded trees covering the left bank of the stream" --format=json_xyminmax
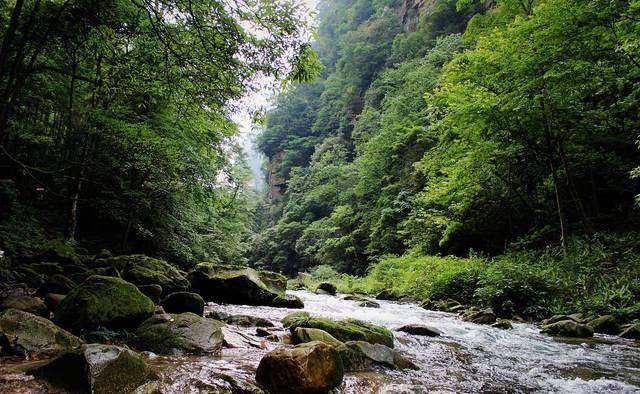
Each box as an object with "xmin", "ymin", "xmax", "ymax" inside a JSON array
[{"xmin": 0, "ymin": 0, "xmax": 318, "ymax": 263}]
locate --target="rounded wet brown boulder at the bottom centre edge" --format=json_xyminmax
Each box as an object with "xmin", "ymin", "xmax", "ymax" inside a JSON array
[{"xmin": 256, "ymin": 342, "xmax": 344, "ymax": 394}]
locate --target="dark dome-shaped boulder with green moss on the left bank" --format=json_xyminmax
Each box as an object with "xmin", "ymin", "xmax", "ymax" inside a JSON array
[{"xmin": 54, "ymin": 275, "xmax": 155, "ymax": 332}]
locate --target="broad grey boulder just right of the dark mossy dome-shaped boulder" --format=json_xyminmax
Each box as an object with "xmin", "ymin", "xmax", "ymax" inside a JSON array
[{"xmin": 129, "ymin": 313, "xmax": 224, "ymax": 355}]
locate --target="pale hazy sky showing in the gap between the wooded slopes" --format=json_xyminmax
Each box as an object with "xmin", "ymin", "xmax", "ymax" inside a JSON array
[{"xmin": 231, "ymin": 0, "xmax": 318, "ymax": 191}]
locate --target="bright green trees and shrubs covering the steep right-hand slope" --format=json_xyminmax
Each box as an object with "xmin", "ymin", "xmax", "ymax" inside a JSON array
[{"xmin": 252, "ymin": 0, "xmax": 640, "ymax": 316}]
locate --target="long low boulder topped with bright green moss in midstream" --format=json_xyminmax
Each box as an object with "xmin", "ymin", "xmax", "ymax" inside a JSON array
[{"xmin": 282, "ymin": 312, "xmax": 393, "ymax": 347}]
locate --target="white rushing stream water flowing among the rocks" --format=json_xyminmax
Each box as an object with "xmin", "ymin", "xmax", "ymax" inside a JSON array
[{"xmin": 0, "ymin": 291, "xmax": 640, "ymax": 394}]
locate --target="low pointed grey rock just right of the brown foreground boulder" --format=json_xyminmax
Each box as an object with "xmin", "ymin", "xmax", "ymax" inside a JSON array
[{"xmin": 337, "ymin": 341, "xmax": 418, "ymax": 372}]
